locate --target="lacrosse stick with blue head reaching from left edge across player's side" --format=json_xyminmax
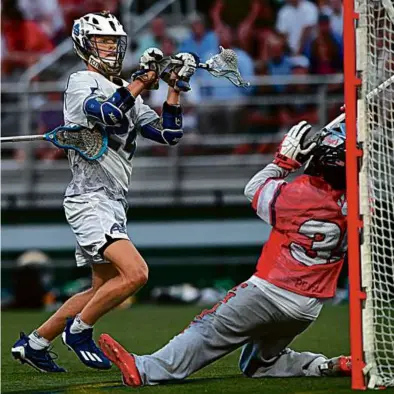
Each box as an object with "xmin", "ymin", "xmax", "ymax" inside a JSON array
[{"xmin": 0, "ymin": 126, "xmax": 108, "ymax": 160}]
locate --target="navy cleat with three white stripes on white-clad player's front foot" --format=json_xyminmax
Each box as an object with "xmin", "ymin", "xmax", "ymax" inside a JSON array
[{"xmin": 62, "ymin": 319, "xmax": 112, "ymax": 369}]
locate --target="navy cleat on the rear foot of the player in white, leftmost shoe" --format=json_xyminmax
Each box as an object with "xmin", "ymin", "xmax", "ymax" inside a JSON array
[{"xmin": 11, "ymin": 332, "xmax": 66, "ymax": 372}]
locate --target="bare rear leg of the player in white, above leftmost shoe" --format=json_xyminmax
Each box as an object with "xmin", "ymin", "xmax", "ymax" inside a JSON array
[{"xmin": 36, "ymin": 264, "xmax": 118, "ymax": 342}]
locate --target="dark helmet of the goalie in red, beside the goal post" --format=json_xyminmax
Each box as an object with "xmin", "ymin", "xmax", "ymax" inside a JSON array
[{"xmin": 304, "ymin": 123, "xmax": 346, "ymax": 190}]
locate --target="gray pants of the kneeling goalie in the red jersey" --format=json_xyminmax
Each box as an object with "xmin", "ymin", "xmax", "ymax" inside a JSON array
[{"xmin": 135, "ymin": 281, "xmax": 326, "ymax": 385}]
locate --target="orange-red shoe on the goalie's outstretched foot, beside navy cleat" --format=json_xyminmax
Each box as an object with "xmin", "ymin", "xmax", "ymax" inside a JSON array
[{"xmin": 99, "ymin": 334, "xmax": 142, "ymax": 387}]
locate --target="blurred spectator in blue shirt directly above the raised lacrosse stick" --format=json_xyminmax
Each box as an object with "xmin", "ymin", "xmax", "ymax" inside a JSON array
[{"xmin": 178, "ymin": 14, "xmax": 219, "ymax": 61}]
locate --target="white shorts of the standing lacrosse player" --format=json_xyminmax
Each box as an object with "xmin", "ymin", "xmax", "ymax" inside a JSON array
[{"xmin": 63, "ymin": 191, "xmax": 129, "ymax": 267}]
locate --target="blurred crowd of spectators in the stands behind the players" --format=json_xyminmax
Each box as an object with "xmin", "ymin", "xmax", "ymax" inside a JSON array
[{"xmin": 1, "ymin": 0, "xmax": 343, "ymax": 160}]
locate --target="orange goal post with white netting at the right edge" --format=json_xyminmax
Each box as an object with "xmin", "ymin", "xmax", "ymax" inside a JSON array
[{"xmin": 344, "ymin": 0, "xmax": 394, "ymax": 390}]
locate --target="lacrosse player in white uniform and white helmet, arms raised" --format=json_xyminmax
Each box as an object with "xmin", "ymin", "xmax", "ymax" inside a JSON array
[{"xmin": 12, "ymin": 12, "xmax": 198, "ymax": 372}]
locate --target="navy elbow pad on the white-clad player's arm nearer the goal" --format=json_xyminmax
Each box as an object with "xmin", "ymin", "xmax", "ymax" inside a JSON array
[{"xmin": 141, "ymin": 102, "xmax": 183, "ymax": 145}]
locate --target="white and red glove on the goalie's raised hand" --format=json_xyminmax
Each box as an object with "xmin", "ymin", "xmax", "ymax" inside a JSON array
[{"xmin": 274, "ymin": 120, "xmax": 316, "ymax": 171}]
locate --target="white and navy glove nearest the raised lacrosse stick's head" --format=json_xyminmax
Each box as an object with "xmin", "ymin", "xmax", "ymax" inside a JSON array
[{"xmin": 161, "ymin": 52, "xmax": 200, "ymax": 92}]
